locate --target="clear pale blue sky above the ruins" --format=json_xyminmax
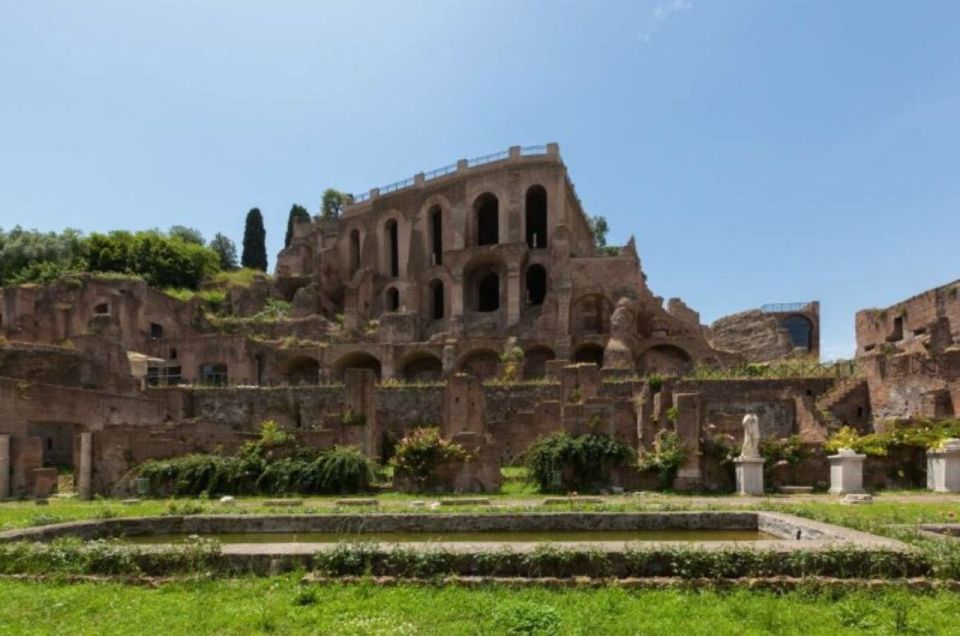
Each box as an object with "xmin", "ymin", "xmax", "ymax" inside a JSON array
[{"xmin": 0, "ymin": 0, "xmax": 960, "ymax": 357}]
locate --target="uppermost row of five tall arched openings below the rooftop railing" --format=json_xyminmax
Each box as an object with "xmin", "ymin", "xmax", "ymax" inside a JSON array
[{"xmin": 349, "ymin": 184, "xmax": 548, "ymax": 278}]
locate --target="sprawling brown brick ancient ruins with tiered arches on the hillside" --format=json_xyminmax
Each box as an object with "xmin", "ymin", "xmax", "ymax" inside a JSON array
[{"xmin": 0, "ymin": 144, "xmax": 960, "ymax": 497}]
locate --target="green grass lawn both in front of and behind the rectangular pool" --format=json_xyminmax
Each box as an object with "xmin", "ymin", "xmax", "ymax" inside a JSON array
[{"xmin": 0, "ymin": 492, "xmax": 960, "ymax": 635}]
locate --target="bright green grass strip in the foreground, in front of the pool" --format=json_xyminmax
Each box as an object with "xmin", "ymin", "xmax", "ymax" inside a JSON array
[{"xmin": 0, "ymin": 575, "xmax": 960, "ymax": 636}]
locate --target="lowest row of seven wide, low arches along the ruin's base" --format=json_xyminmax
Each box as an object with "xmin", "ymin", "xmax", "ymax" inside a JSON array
[{"xmin": 281, "ymin": 342, "xmax": 692, "ymax": 384}]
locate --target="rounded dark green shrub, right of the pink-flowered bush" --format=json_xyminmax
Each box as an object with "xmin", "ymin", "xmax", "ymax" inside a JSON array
[{"xmin": 525, "ymin": 432, "xmax": 633, "ymax": 492}]
